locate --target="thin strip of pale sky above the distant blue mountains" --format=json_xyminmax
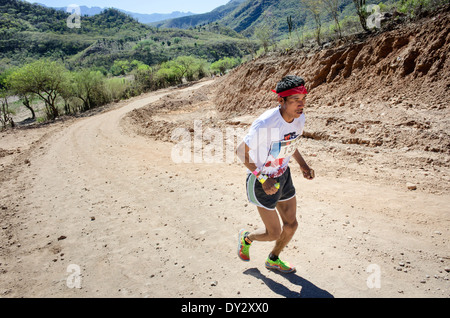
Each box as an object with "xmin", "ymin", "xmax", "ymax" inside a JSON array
[{"xmin": 27, "ymin": 0, "xmax": 230, "ymax": 14}]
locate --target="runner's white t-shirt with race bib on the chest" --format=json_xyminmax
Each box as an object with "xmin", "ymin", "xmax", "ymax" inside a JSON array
[{"xmin": 244, "ymin": 106, "xmax": 305, "ymax": 178}]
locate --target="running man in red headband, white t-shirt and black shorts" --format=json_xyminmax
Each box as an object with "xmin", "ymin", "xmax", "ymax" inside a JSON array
[{"xmin": 237, "ymin": 76, "xmax": 314, "ymax": 273}]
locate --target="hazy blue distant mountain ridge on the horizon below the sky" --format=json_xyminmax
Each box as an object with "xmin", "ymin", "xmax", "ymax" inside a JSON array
[{"xmin": 38, "ymin": 3, "xmax": 195, "ymax": 23}]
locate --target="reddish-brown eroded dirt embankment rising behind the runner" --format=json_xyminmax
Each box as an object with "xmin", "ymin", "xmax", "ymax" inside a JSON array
[{"xmin": 216, "ymin": 6, "xmax": 450, "ymax": 154}]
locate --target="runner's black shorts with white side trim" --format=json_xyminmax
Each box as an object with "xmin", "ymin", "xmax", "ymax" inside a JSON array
[{"xmin": 247, "ymin": 167, "xmax": 296, "ymax": 210}]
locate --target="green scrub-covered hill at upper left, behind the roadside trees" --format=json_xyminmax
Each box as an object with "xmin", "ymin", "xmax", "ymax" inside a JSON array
[{"xmin": 0, "ymin": 0, "xmax": 256, "ymax": 71}]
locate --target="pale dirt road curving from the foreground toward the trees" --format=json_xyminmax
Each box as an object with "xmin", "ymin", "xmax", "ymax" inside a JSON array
[{"xmin": 0, "ymin": 82, "xmax": 450, "ymax": 297}]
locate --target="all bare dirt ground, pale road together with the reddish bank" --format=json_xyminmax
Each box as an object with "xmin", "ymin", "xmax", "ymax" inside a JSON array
[{"xmin": 0, "ymin": 11, "xmax": 450, "ymax": 298}]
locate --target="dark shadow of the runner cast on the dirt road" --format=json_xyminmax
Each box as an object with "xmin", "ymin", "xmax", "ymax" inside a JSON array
[{"xmin": 244, "ymin": 268, "xmax": 334, "ymax": 298}]
